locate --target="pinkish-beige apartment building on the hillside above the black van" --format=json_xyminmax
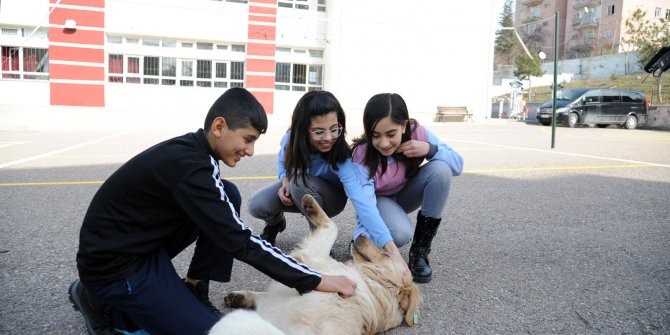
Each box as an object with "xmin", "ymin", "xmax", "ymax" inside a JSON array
[{"xmin": 515, "ymin": 0, "xmax": 670, "ymax": 59}]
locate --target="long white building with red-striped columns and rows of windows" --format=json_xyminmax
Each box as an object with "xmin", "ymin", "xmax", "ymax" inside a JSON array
[{"xmin": 0, "ymin": 0, "xmax": 497, "ymax": 121}]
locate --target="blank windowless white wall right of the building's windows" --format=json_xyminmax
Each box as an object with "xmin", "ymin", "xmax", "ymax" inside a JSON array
[{"xmin": 326, "ymin": 0, "xmax": 495, "ymax": 122}]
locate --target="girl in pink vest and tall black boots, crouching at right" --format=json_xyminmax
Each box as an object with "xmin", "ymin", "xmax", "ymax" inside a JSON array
[{"xmin": 353, "ymin": 93, "xmax": 463, "ymax": 283}]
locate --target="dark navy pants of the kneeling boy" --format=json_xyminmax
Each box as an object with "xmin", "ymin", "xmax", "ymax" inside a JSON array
[{"xmin": 86, "ymin": 180, "xmax": 242, "ymax": 335}]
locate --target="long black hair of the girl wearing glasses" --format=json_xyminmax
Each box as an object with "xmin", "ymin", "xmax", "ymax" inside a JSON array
[{"xmin": 284, "ymin": 91, "xmax": 351, "ymax": 185}]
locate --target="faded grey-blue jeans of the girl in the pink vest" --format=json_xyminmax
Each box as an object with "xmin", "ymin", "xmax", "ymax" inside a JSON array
[{"xmin": 377, "ymin": 160, "xmax": 452, "ymax": 247}]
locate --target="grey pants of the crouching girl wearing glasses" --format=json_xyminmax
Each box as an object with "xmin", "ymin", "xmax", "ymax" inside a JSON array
[{"xmin": 248, "ymin": 176, "xmax": 347, "ymax": 230}]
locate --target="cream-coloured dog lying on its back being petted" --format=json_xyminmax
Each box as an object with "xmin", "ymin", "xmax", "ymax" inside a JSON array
[{"xmin": 210, "ymin": 195, "xmax": 421, "ymax": 335}]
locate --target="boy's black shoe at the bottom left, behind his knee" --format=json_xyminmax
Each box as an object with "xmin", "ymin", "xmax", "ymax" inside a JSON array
[{"xmin": 68, "ymin": 279, "xmax": 119, "ymax": 335}]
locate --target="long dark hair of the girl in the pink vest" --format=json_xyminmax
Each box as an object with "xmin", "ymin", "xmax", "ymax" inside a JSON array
[{"xmin": 352, "ymin": 93, "xmax": 424, "ymax": 178}]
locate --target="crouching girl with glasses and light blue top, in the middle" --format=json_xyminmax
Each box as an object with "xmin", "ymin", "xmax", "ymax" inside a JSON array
[{"xmin": 249, "ymin": 91, "xmax": 402, "ymax": 270}]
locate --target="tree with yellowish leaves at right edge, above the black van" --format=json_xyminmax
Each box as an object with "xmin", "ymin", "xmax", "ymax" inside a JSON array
[{"xmin": 623, "ymin": 8, "xmax": 670, "ymax": 103}]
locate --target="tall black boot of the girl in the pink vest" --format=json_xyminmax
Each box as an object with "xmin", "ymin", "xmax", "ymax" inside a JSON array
[{"xmin": 409, "ymin": 211, "xmax": 442, "ymax": 283}]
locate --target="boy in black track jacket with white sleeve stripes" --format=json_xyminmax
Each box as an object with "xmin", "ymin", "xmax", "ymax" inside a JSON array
[{"xmin": 69, "ymin": 88, "xmax": 355, "ymax": 334}]
